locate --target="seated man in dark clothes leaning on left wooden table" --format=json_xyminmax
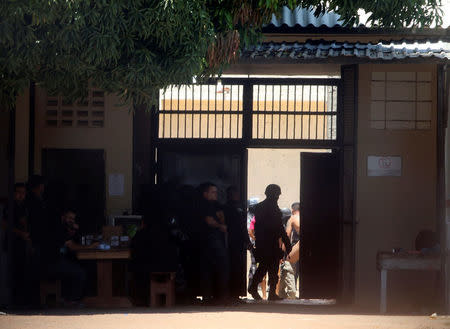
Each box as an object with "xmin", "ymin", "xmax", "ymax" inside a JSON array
[{"xmin": 41, "ymin": 209, "xmax": 98, "ymax": 305}]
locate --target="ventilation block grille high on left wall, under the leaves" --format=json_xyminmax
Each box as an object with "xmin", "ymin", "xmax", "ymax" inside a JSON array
[{"xmin": 45, "ymin": 90, "xmax": 105, "ymax": 128}]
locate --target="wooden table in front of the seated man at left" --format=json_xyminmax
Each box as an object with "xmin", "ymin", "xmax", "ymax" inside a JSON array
[{"xmin": 77, "ymin": 249, "xmax": 132, "ymax": 307}]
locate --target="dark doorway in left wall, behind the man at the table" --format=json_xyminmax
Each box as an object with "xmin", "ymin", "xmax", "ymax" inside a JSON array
[{"xmin": 42, "ymin": 149, "xmax": 105, "ymax": 233}]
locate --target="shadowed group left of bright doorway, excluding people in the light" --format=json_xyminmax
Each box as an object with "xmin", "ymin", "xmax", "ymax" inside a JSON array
[{"xmin": 131, "ymin": 182, "xmax": 250, "ymax": 304}]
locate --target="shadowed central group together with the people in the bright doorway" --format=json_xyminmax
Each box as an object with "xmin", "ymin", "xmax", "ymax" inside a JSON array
[{"xmin": 132, "ymin": 182, "xmax": 299, "ymax": 305}]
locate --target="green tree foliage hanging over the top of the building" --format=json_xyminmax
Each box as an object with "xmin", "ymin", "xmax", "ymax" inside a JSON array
[{"xmin": 0, "ymin": 0, "xmax": 441, "ymax": 108}]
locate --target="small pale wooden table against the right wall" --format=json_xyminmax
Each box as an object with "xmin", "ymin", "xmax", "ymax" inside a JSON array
[{"xmin": 377, "ymin": 252, "xmax": 441, "ymax": 313}]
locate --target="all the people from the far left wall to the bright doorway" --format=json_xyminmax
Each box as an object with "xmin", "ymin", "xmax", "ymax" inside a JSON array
[{"xmin": 2, "ymin": 176, "xmax": 299, "ymax": 307}]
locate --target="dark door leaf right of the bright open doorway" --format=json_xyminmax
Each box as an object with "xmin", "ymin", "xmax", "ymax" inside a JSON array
[{"xmin": 300, "ymin": 152, "xmax": 340, "ymax": 299}]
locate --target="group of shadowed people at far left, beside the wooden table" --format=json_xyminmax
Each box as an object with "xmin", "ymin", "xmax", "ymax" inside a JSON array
[{"xmin": 2, "ymin": 175, "xmax": 96, "ymax": 307}]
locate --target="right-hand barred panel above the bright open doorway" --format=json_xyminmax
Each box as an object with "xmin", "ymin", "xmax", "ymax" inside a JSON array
[{"xmin": 252, "ymin": 84, "xmax": 337, "ymax": 140}]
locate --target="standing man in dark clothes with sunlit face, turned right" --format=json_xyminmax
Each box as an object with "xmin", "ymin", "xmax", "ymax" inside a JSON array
[{"xmin": 199, "ymin": 183, "xmax": 228, "ymax": 303}]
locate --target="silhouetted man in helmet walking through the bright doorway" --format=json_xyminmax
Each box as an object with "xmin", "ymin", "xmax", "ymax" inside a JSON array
[{"xmin": 248, "ymin": 184, "xmax": 291, "ymax": 300}]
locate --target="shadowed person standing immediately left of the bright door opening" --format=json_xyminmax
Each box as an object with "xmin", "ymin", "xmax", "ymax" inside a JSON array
[{"xmin": 224, "ymin": 186, "xmax": 250, "ymax": 299}]
